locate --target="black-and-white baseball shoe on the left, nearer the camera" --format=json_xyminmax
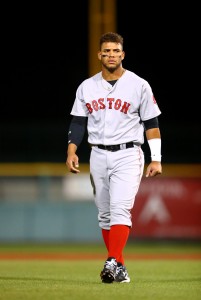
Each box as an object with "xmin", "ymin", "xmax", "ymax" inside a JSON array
[{"xmin": 100, "ymin": 257, "xmax": 117, "ymax": 283}]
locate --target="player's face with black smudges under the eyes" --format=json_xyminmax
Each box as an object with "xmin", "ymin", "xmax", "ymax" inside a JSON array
[{"xmin": 98, "ymin": 42, "xmax": 125, "ymax": 71}]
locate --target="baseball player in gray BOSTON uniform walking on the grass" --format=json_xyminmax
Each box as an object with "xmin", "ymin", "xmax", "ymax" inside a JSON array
[{"xmin": 66, "ymin": 32, "xmax": 162, "ymax": 283}]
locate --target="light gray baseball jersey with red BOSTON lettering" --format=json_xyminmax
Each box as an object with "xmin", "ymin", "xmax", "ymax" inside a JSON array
[{"xmin": 71, "ymin": 70, "xmax": 161, "ymax": 145}]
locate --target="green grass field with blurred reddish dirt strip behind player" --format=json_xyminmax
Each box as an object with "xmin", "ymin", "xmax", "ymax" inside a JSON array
[{"xmin": 0, "ymin": 242, "xmax": 201, "ymax": 300}]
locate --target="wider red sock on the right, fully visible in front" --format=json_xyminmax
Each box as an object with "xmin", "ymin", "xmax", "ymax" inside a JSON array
[{"xmin": 108, "ymin": 225, "xmax": 130, "ymax": 264}]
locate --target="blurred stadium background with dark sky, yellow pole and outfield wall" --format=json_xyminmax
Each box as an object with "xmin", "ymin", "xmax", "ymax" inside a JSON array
[{"xmin": 0, "ymin": 0, "xmax": 201, "ymax": 243}]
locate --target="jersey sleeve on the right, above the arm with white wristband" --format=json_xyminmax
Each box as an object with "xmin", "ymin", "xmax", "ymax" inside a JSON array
[{"xmin": 140, "ymin": 81, "xmax": 161, "ymax": 121}]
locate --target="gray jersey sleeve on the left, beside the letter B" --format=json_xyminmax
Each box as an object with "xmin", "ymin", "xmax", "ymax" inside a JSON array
[{"xmin": 71, "ymin": 83, "xmax": 88, "ymax": 117}]
